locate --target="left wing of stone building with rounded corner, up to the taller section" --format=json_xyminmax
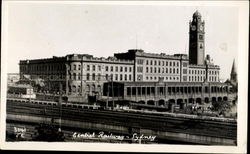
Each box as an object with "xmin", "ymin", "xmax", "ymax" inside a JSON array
[{"xmin": 19, "ymin": 54, "xmax": 134, "ymax": 101}]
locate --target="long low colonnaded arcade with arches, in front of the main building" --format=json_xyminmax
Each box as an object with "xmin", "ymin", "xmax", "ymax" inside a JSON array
[{"xmin": 103, "ymin": 80, "xmax": 234, "ymax": 110}]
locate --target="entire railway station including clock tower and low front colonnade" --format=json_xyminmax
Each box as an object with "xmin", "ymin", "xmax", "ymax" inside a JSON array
[{"xmin": 19, "ymin": 11, "xmax": 236, "ymax": 106}]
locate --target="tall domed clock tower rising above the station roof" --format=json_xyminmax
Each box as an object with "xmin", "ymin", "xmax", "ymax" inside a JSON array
[{"xmin": 189, "ymin": 11, "xmax": 205, "ymax": 65}]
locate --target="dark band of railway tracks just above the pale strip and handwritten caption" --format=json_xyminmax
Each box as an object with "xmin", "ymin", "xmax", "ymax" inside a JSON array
[{"xmin": 7, "ymin": 102, "xmax": 237, "ymax": 139}]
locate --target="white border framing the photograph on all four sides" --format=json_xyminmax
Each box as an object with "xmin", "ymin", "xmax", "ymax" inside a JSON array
[{"xmin": 0, "ymin": 1, "xmax": 249, "ymax": 153}]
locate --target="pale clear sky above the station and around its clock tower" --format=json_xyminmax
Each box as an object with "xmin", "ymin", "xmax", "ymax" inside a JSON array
[{"xmin": 3, "ymin": 3, "xmax": 239, "ymax": 80}]
